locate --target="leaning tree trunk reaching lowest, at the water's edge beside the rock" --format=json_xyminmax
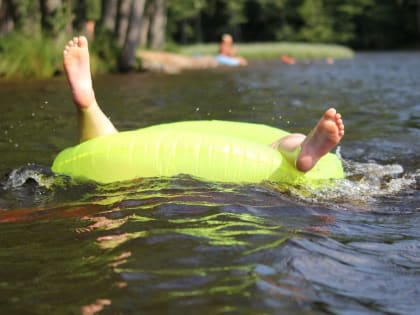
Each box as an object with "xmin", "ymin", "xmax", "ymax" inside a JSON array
[{"xmin": 119, "ymin": 0, "xmax": 146, "ymax": 71}]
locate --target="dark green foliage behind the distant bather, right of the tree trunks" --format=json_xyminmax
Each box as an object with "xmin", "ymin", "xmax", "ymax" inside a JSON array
[{"xmin": 168, "ymin": 0, "xmax": 420, "ymax": 49}]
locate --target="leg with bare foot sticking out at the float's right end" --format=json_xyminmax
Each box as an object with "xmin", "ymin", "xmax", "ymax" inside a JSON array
[{"xmin": 271, "ymin": 108, "xmax": 344, "ymax": 172}]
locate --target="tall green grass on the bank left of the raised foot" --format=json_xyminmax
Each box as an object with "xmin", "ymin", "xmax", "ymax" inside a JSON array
[{"xmin": 0, "ymin": 33, "xmax": 62, "ymax": 77}]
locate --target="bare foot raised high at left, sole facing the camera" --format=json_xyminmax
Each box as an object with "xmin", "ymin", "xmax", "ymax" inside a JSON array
[{"xmin": 63, "ymin": 36, "xmax": 96, "ymax": 109}]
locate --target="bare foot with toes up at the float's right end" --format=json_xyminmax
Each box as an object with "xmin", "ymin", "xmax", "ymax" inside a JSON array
[{"xmin": 296, "ymin": 108, "xmax": 344, "ymax": 172}]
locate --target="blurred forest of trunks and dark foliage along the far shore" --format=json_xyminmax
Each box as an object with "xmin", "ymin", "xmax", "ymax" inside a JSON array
[{"xmin": 0, "ymin": 0, "xmax": 420, "ymax": 74}]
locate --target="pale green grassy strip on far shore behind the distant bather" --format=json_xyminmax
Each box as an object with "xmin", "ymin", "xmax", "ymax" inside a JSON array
[{"xmin": 179, "ymin": 42, "xmax": 354, "ymax": 59}]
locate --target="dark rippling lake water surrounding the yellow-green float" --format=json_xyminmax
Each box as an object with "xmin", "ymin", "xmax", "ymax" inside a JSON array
[{"xmin": 0, "ymin": 53, "xmax": 420, "ymax": 314}]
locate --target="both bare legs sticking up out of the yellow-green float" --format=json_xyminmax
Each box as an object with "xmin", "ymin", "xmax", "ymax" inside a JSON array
[{"xmin": 63, "ymin": 36, "xmax": 344, "ymax": 172}]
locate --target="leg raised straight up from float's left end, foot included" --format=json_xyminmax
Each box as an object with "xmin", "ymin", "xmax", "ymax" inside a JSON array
[{"xmin": 63, "ymin": 36, "xmax": 118, "ymax": 142}]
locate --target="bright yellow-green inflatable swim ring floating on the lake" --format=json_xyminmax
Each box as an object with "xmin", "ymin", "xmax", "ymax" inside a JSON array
[{"xmin": 52, "ymin": 120, "xmax": 344, "ymax": 184}]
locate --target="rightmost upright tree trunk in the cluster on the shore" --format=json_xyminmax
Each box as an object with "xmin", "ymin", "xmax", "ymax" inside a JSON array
[{"xmin": 150, "ymin": 0, "xmax": 166, "ymax": 49}]
